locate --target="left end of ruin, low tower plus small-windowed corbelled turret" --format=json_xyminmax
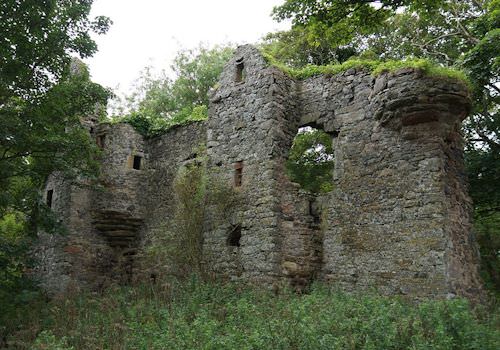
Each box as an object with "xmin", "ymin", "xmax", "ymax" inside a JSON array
[{"xmin": 35, "ymin": 124, "xmax": 144, "ymax": 293}]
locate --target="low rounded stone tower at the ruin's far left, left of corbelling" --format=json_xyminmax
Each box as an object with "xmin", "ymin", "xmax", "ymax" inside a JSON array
[{"xmin": 34, "ymin": 173, "xmax": 112, "ymax": 294}]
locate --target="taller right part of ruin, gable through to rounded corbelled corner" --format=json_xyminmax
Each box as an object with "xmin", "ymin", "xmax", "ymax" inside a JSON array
[{"xmin": 204, "ymin": 47, "xmax": 480, "ymax": 297}]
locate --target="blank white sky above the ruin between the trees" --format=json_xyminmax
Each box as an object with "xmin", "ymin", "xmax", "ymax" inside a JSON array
[{"xmin": 85, "ymin": 0, "xmax": 288, "ymax": 93}]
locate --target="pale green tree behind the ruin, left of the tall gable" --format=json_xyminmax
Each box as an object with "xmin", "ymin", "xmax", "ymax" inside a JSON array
[{"xmin": 118, "ymin": 46, "xmax": 233, "ymax": 136}]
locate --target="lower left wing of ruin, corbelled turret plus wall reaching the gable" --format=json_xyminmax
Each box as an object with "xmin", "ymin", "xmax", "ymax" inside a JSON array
[{"xmin": 35, "ymin": 123, "xmax": 206, "ymax": 293}]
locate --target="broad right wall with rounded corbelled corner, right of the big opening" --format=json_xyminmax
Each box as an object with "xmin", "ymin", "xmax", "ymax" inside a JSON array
[{"xmin": 304, "ymin": 70, "xmax": 479, "ymax": 297}]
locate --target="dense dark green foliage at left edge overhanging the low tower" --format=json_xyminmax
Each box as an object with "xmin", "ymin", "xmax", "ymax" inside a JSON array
[{"xmin": 0, "ymin": 62, "xmax": 108, "ymax": 219}]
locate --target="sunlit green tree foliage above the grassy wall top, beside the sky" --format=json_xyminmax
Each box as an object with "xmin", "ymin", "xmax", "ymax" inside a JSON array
[{"xmin": 264, "ymin": 0, "xmax": 448, "ymax": 67}]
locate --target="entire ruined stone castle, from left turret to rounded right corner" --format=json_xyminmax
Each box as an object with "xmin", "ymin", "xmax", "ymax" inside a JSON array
[{"xmin": 37, "ymin": 46, "xmax": 481, "ymax": 298}]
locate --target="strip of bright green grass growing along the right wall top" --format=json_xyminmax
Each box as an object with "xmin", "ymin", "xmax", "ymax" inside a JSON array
[{"xmin": 262, "ymin": 52, "xmax": 471, "ymax": 86}]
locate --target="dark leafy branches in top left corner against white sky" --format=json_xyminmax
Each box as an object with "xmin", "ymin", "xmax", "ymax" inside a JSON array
[{"xmin": 0, "ymin": 0, "xmax": 111, "ymax": 101}]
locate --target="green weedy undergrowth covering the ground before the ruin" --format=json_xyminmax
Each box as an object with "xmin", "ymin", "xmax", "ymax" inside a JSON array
[{"xmin": 5, "ymin": 278, "xmax": 500, "ymax": 350}]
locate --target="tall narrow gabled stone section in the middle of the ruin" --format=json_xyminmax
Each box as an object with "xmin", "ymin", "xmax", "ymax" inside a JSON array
[{"xmin": 205, "ymin": 47, "xmax": 296, "ymax": 282}]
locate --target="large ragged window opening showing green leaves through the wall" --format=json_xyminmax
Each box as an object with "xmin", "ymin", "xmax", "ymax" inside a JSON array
[{"xmin": 286, "ymin": 126, "xmax": 334, "ymax": 193}]
